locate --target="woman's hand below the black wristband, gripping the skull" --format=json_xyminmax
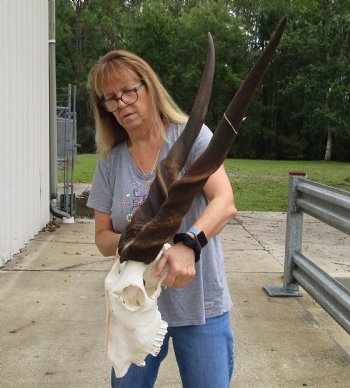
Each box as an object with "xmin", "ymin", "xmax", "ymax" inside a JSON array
[{"xmin": 155, "ymin": 242, "xmax": 196, "ymax": 288}]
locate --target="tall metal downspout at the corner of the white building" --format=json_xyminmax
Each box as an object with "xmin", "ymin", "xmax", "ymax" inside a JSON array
[{"xmin": 48, "ymin": 0, "xmax": 71, "ymax": 219}]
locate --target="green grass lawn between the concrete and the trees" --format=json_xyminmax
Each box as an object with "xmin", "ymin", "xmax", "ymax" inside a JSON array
[{"xmin": 65, "ymin": 154, "xmax": 350, "ymax": 211}]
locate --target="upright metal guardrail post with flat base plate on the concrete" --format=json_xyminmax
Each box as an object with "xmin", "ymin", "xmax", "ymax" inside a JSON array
[{"xmin": 264, "ymin": 171, "xmax": 306, "ymax": 297}]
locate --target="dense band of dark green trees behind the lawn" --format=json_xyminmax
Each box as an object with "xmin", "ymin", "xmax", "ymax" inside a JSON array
[{"xmin": 56, "ymin": 0, "xmax": 350, "ymax": 161}]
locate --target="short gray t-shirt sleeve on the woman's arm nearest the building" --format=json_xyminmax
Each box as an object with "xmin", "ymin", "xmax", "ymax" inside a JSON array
[{"xmin": 86, "ymin": 158, "xmax": 113, "ymax": 214}]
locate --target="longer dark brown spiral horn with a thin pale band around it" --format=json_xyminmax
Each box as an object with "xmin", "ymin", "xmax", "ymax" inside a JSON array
[{"xmin": 119, "ymin": 17, "xmax": 287, "ymax": 263}]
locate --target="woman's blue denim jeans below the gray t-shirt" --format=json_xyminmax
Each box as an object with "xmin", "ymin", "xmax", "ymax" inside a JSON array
[{"xmin": 111, "ymin": 313, "xmax": 234, "ymax": 388}]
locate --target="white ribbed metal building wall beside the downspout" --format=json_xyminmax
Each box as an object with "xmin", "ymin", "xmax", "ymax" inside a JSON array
[{"xmin": 0, "ymin": 0, "xmax": 50, "ymax": 267}]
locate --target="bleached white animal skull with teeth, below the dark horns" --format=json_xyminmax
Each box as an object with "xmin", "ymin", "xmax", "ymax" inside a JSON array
[{"xmin": 105, "ymin": 244, "xmax": 170, "ymax": 377}]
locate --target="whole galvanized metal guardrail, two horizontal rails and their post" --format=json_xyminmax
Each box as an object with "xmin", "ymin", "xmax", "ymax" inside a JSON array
[{"xmin": 264, "ymin": 172, "xmax": 350, "ymax": 334}]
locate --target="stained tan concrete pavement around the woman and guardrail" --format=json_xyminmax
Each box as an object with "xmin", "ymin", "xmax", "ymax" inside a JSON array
[{"xmin": 0, "ymin": 212, "xmax": 350, "ymax": 388}]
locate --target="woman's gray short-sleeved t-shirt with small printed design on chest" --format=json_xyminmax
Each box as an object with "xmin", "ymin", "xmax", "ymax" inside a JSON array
[{"xmin": 87, "ymin": 124, "xmax": 232, "ymax": 326}]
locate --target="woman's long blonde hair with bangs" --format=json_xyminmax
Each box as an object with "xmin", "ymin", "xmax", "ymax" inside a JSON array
[{"xmin": 88, "ymin": 50, "xmax": 188, "ymax": 158}]
